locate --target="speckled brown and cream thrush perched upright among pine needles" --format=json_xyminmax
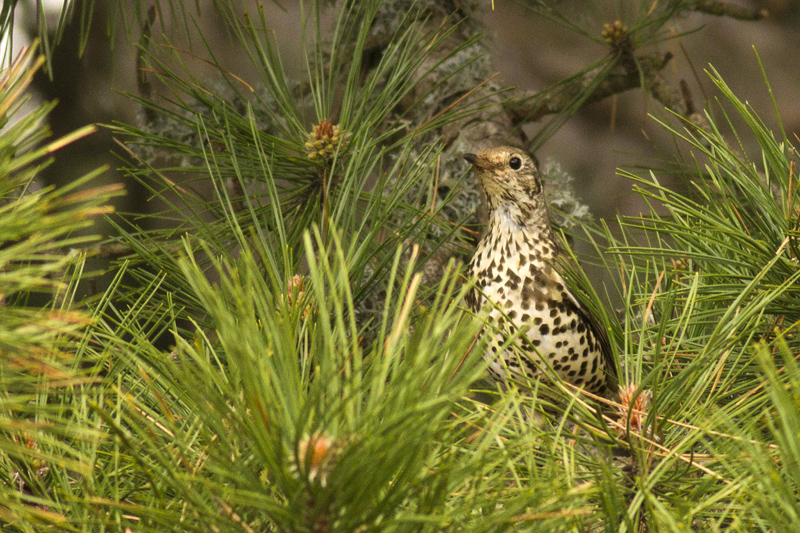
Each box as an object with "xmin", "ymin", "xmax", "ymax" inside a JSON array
[{"xmin": 463, "ymin": 146, "xmax": 618, "ymax": 397}]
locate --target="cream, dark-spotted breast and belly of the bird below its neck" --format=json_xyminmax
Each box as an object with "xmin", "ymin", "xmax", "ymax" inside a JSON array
[{"xmin": 470, "ymin": 222, "xmax": 606, "ymax": 392}]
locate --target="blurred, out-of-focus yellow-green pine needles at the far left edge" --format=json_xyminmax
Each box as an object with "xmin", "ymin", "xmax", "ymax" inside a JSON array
[{"xmin": 0, "ymin": 44, "xmax": 120, "ymax": 531}]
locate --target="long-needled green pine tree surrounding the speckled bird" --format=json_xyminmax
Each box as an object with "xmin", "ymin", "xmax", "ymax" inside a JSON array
[{"xmin": 0, "ymin": 0, "xmax": 800, "ymax": 532}]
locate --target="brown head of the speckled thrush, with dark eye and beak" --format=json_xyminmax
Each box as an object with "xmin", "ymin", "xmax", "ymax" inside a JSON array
[{"xmin": 464, "ymin": 146, "xmax": 546, "ymax": 223}]
